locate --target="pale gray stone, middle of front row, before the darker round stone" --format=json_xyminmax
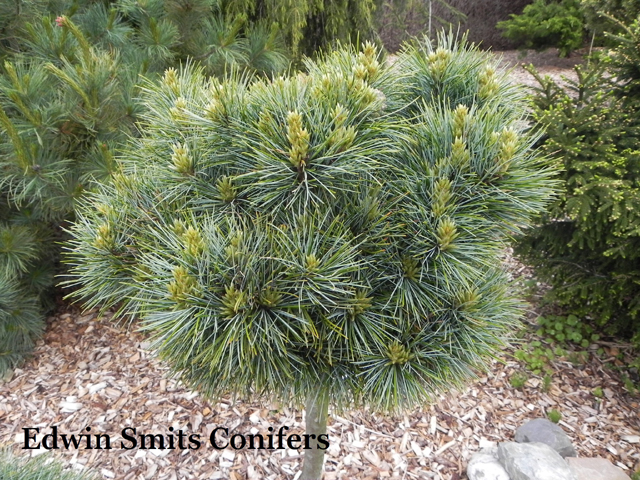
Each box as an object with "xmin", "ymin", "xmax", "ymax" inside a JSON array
[{"xmin": 498, "ymin": 442, "xmax": 583, "ymax": 480}]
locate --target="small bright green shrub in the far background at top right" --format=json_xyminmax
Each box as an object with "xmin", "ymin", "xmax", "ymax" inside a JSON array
[{"xmin": 498, "ymin": 0, "xmax": 585, "ymax": 57}]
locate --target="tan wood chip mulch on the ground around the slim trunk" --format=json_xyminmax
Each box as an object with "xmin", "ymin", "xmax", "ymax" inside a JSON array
[{"xmin": 0, "ymin": 302, "xmax": 640, "ymax": 480}]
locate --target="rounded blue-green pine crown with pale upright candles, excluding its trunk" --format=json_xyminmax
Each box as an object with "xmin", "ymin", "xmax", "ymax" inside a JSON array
[{"xmin": 68, "ymin": 38, "xmax": 552, "ymax": 410}]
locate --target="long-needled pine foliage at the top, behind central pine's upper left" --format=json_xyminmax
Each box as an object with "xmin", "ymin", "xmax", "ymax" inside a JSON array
[{"xmin": 110, "ymin": 0, "xmax": 288, "ymax": 75}]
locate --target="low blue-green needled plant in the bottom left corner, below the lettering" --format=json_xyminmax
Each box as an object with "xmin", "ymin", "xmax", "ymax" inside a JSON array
[{"xmin": 0, "ymin": 450, "xmax": 99, "ymax": 480}]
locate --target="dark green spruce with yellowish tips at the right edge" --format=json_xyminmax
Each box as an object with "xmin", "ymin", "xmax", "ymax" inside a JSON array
[{"xmin": 518, "ymin": 63, "xmax": 640, "ymax": 344}]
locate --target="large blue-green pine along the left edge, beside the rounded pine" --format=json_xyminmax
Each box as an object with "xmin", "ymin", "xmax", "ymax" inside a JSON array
[{"xmin": 0, "ymin": 13, "xmax": 137, "ymax": 371}]
